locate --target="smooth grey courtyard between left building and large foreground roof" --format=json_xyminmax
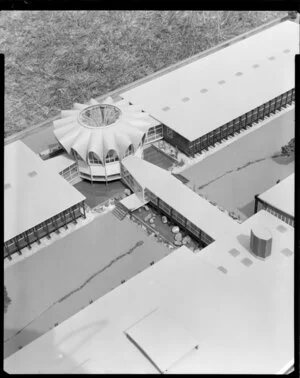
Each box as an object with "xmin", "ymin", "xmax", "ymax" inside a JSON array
[{"xmin": 4, "ymin": 213, "xmax": 171, "ymax": 357}]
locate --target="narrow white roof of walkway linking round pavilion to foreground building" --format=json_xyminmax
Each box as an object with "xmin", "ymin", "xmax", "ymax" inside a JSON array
[{"xmin": 122, "ymin": 156, "xmax": 238, "ymax": 240}]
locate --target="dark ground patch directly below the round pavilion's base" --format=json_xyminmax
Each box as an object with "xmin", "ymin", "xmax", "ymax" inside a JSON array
[{"xmin": 74, "ymin": 180, "xmax": 125, "ymax": 208}]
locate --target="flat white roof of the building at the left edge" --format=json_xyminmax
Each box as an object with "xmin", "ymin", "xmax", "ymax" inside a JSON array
[{"xmin": 4, "ymin": 141, "xmax": 85, "ymax": 241}]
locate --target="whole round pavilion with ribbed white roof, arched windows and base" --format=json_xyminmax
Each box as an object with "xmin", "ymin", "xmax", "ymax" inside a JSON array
[{"xmin": 53, "ymin": 97, "xmax": 159, "ymax": 181}]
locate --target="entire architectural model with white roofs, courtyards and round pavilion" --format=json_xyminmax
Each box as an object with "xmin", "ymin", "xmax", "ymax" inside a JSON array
[{"xmin": 4, "ymin": 15, "xmax": 299, "ymax": 374}]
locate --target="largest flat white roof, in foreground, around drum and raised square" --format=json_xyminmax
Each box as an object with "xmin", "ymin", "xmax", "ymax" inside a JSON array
[{"xmin": 4, "ymin": 210, "xmax": 294, "ymax": 374}]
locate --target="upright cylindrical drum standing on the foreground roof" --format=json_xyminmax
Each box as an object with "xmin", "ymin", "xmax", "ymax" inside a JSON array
[{"xmin": 250, "ymin": 225, "xmax": 272, "ymax": 258}]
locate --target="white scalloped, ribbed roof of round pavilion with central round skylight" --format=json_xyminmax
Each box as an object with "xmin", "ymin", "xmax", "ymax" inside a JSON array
[{"xmin": 53, "ymin": 97, "xmax": 159, "ymax": 162}]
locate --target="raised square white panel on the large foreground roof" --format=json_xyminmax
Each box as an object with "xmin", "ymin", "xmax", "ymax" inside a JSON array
[{"xmin": 126, "ymin": 309, "xmax": 199, "ymax": 373}]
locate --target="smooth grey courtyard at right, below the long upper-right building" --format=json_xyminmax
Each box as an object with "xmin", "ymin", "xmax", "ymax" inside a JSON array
[{"xmin": 181, "ymin": 108, "xmax": 295, "ymax": 220}]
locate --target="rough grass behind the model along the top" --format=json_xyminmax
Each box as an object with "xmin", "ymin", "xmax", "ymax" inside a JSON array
[{"xmin": 0, "ymin": 10, "xmax": 287, "ymax": 136}]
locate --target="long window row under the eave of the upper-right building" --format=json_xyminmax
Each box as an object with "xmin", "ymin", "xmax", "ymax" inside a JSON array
[{"xmin": 189, "ymin": 89, "xmax": 295, "ymax": 154}]
